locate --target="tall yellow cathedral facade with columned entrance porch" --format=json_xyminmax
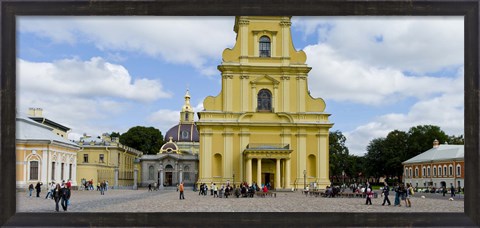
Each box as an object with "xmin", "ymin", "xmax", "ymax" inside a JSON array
[{"xmin": 197, "ymin": 16, "xmax": 333, "ymax": 190}]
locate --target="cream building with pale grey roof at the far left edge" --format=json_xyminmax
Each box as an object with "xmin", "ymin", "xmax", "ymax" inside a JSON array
[{"xmin": 15, "ymin": 116, "xmax": 79, "ymax": 188}]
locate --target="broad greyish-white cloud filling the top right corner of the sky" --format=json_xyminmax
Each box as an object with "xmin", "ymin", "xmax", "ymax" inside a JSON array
[{"xmin": 294, "ymin": 17, "xmax": 464, "ymax": 74}]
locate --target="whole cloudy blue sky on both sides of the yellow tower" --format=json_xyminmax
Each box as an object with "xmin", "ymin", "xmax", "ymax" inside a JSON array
[{"xmin": 17, "ymin": 16, "xmax": 464, "ymax": 155}]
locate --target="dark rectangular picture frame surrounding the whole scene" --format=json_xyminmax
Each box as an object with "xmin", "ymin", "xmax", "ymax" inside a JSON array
[{"xmin": 0, "ymin": 0, "xmax": 480, "ymax": 227}]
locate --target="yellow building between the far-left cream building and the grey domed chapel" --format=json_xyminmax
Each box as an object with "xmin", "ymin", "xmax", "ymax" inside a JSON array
[{"xmin": 76, "ymin": 134, "xmax": 143, "ymax": 188}]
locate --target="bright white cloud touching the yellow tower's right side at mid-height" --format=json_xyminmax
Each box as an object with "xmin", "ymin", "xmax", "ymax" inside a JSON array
[{"xmin": 305, "ymin": 44, "xmax": 463, "ymax": 105}]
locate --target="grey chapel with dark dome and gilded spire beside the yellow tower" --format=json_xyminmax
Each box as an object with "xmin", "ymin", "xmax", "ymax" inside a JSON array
[{"xmin": 140, "ymin": 91, "xmax": 199, "ymax": 188}]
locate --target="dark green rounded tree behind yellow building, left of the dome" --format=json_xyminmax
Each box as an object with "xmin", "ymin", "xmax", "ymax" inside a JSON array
[{"xmin": 120, "ymin": 126, "xmax": 163, "ymax": 154}]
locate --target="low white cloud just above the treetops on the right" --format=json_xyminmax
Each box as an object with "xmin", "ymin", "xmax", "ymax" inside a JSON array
[{"xmin": 345, "ymin": 68, "xmax": 464, "ymax": 155}]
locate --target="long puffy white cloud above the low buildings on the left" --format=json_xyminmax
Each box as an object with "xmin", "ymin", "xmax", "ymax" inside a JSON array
[{"xmin": 17, "ymin": 57, "xmax": 171, "ymax": 102}]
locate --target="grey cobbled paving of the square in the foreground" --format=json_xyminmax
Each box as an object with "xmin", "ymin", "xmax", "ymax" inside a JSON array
[{"xmin": 17, "ymin": 189, "xmax": 464, "ymax": 213}]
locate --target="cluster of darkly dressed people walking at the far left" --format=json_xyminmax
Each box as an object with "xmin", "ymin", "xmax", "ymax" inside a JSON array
[{"xmin": 28, "ymin": 180, "xmax": 72, "ymax": 212}]
